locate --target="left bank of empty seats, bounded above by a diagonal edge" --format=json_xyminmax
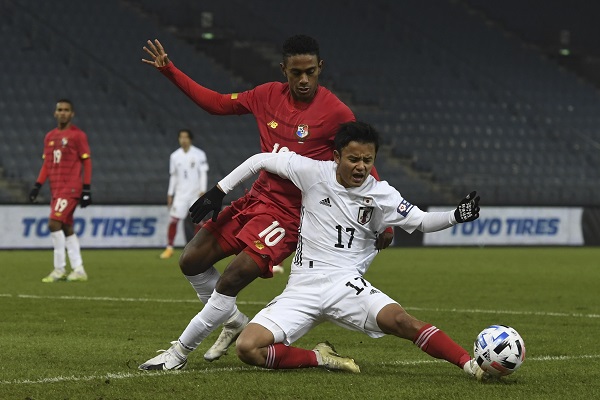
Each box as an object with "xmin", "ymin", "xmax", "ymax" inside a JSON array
[{"xmin": 0, "ymin": 0, "xmax": 259, "ymax": 203}]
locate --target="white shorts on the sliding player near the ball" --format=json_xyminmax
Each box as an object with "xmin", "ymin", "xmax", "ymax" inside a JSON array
[{"xmin": 251, "ymin": 272, "xmax": 398, "ymax": 345}]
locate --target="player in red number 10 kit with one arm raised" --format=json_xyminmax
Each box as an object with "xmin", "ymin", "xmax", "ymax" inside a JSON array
[{"xmin": 140, "ymin": 35, "xmax": 392, "ymax": 370}]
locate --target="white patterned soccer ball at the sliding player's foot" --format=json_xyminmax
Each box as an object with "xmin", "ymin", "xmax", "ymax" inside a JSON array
[{"xmin": 473, "ymin": 325, "xmax": 525, "ymax": 377}]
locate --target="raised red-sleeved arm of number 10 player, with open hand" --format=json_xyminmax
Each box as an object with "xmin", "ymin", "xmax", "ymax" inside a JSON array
[{"xmin": 142, "ymin": 39, "xmax": 247, "ymax": 115}]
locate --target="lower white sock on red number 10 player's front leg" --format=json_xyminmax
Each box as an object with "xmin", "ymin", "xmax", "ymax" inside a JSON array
[{"xmin": 179, "ymin": 291, "xmax": 238, "ymax": 349}]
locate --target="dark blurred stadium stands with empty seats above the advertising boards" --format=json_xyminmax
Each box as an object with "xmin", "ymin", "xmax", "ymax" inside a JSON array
[{"xmin": 0, "ymin": 0, "xmax": 600, "ymax": 207}]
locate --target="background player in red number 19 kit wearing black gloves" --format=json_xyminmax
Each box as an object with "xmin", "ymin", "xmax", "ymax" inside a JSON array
[{"xmin": 29, "ymin": 99, "xmax": 92, "ymax": 282}]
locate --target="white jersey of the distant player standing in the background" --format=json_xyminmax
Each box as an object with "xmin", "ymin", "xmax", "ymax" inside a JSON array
[{"xmin": 167, "ymin": 146, "xmax": 208, "ymax": 199}]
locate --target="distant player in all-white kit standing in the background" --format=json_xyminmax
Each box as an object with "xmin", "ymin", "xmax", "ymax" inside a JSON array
[{"xmin": 160, "ymin": 129, "xmax": 208, "ymax": 258}]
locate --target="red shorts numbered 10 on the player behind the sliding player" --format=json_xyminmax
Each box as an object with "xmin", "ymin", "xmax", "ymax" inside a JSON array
[{"xmin": 203, "ymin": 194, "xmax": 300, "ymax": 278}]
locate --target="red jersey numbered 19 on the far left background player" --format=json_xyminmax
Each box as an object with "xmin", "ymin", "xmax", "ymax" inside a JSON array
[{"xmin": 40, "ymin": 125, "xmax": 90, "ymax": 197}]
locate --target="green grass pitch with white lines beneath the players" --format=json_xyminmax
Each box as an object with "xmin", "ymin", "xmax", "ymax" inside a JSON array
[{"xmin": 0, "ymin": 248, "xmax": 600, "ymax": 400}]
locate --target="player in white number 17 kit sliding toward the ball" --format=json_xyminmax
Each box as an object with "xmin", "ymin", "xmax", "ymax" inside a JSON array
[{"xmin": 182, "ymin": 122, "xmax": 486, "ymax": 379}]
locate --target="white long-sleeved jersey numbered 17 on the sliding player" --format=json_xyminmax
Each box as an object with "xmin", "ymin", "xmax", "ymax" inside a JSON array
[{"xmin": 219, "ymin": 153, "xmax": 456, "ymax": 275}]
